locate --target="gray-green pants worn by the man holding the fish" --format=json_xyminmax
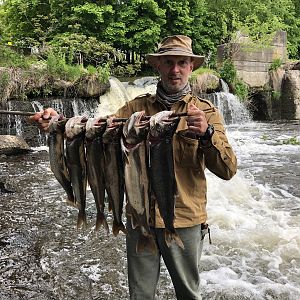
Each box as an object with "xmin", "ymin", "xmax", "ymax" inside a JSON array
[{"xmin": 126, "ymin": 222, "xmax": 207, "ymax": 300}]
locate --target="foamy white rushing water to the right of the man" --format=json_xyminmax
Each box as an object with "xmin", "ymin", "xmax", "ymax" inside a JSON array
[{"xmin": 201, "ymin": 123, "xmax": 300, "ymax": 300}]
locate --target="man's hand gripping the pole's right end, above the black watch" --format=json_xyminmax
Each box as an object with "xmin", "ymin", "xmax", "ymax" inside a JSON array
[{"xmin": 186, "ymin": 104, "xmax": 208, "ymax": 135}]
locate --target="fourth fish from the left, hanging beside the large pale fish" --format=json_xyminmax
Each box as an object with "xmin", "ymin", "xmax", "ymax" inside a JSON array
[{"xmin": 102, "ymin": 117, "xmax": 127, "ymax": 236}]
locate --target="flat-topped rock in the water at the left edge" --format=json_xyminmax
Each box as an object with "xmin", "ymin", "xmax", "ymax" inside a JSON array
[{"xmin": 0, "ymin": 135, "xmax": 31, "ymax": 155}]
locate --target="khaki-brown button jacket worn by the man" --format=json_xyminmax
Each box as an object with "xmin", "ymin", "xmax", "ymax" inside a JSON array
[{"xmin": 116, "ymin": 94, "xmax": 237, "ymax": 228}]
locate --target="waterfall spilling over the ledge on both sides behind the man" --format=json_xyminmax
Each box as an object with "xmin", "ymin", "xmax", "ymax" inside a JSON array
[{"xmin": 0, "ymin": 77, "xmax": 251, "ymax": 145}]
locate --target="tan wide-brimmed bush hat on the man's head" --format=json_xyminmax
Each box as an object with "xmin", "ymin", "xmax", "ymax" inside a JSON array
[{"xmin": 146, "ymin": 35, "xmax": 204, "ymax": 70}]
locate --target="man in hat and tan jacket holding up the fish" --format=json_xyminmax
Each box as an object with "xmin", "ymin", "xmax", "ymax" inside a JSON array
[{"xmin": 34, "ymin": 35, "xmax": 237, "ymax": 300}]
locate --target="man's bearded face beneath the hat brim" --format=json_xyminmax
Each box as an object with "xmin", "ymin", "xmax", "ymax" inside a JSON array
[{"xmin": 157, "ymin": 55, "xmax": 193, "ymax": 94}]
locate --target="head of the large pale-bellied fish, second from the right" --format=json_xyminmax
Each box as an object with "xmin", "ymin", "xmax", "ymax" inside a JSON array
[{"xmin": 123, "ymin": 111, "xmax": 150, "ymax": 144}]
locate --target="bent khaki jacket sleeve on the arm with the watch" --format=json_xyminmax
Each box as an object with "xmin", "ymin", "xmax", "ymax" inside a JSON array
[{"xmin": 199, "ymin": 111, "xmax": 237, "ymax": 180}]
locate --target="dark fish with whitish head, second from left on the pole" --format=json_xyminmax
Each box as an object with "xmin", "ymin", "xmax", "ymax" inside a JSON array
[{"xmin": 66, "ymin": 116, "xmax": 87, "ymax": 228}]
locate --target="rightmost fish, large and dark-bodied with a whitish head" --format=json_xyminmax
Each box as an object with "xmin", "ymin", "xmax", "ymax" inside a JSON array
[{"xmin": 148, "ymin": 111, "xmax": 184, "ymax": 249}]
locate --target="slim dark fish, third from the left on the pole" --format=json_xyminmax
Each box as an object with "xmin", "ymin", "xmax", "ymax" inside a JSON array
[{"xmin": 85, "ymin": 118, "xmax": 109, "ymax": 234}]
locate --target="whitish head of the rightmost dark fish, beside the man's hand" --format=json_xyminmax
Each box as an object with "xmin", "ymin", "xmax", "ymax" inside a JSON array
[{"xmin": 149, "ymin": 110, "xmax": 180, "ymax": 138}]
